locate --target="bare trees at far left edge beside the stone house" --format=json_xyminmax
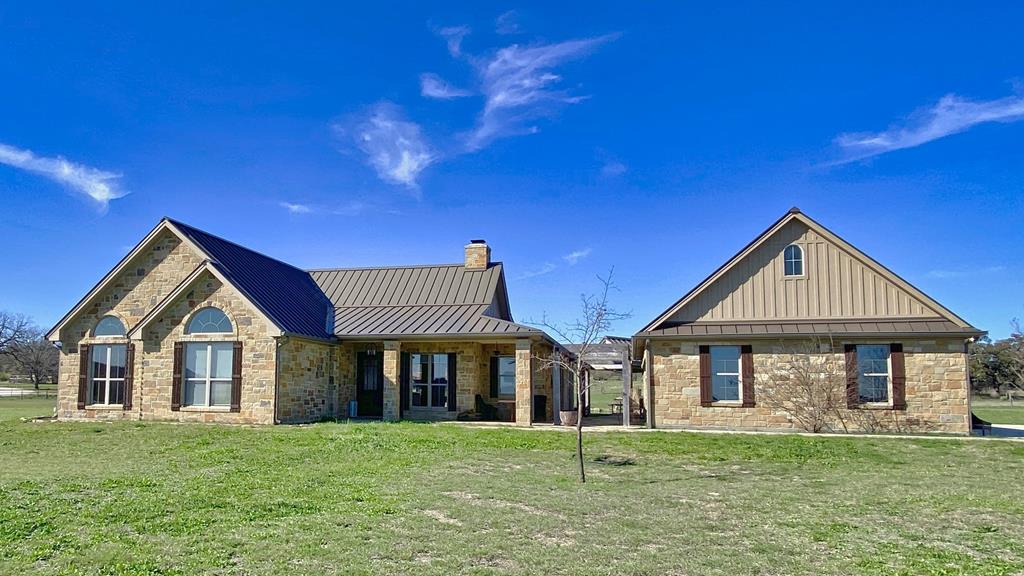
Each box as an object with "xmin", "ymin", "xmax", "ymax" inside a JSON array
[{"xmin": 0, "ymin": 311, "xmax": 59, "ymax": 389}]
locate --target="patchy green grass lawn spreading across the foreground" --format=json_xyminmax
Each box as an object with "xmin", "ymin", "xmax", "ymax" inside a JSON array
[{"xmin": 0, "ymin": 401, "xmax": 1024, "ymax": 575}]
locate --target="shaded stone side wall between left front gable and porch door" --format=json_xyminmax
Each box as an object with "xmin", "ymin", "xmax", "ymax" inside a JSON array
[{"xmin": 278, "ymin": 337, "xmax": 335, "ymax": 423}]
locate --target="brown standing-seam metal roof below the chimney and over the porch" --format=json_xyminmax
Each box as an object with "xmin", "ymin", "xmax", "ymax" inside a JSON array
[{"xmin": 309, "ymin": 262, "xmax": 544, "ymax": 337}]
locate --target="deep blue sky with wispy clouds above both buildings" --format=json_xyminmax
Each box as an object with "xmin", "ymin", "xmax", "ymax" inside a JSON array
[{"xmin": 0, "ymin": 2, "xmax": 1024, "ymax": 337}]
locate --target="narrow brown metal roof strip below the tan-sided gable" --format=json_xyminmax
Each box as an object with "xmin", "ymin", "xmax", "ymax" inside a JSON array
[{"xmin": 636, "ymin": 318, "xmax": 979, "ymax": 338}]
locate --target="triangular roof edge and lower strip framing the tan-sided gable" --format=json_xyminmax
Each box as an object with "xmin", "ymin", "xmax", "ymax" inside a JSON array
[{"xmin": 635, "ymin": 208, "xmax": 983, "ymax": 337}]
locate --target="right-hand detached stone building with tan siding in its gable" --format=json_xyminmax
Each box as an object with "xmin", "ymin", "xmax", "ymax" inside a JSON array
[{"xmin": 633, "ymin": 208, "xmax": 984, "ymax": 434}]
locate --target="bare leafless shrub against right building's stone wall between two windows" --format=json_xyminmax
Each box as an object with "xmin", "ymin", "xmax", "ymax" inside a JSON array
[{"xmin": 757, "ymin": 337, "xmax": 849, "ymax": 433}]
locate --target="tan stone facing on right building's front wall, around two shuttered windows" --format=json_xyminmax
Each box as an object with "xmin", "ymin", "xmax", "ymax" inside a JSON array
[{"xmin": 648, "ymin": 338, "xmax": 971, "ymax": 435}]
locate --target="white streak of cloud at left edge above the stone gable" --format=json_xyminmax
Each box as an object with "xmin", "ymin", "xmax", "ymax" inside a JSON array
[{"xmin": 0, "ymin": 143, "xmax": 128, "ymax": 210}]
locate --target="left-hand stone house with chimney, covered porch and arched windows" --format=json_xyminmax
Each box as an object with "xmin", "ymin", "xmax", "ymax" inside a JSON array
[{"xmin": 47, "ymin": 218, "xmax": 567, "ymax": 424}]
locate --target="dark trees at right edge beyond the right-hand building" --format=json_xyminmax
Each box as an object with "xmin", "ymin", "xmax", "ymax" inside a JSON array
[{"xmin": 969, "ymin": 320, "xmax": 1024, "ymax": 396}]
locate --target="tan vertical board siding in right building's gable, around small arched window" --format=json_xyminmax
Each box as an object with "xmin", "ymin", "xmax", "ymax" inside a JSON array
[{"xmin": 669, "ymin": 220, "xmax": 941, "ymax": 322}]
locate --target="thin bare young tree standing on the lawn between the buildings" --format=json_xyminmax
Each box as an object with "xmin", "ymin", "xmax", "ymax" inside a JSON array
[{"xmin": 530, "ymin": 268, "xmax": 630, "ymax": 483}]
